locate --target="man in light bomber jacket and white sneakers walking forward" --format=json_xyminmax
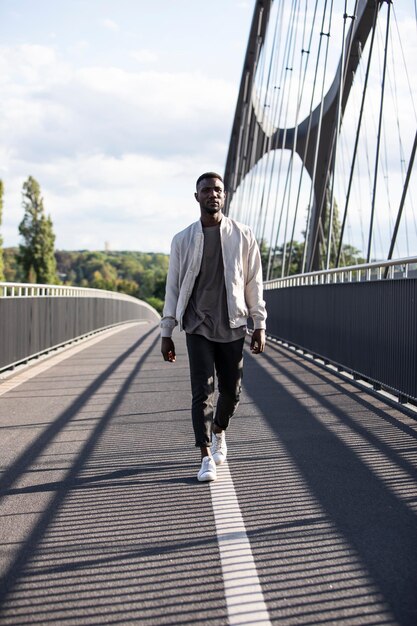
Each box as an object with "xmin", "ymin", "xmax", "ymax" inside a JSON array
[{"xmin": 161, "ymin": 172, "xmax": 266, "ymax": 481}]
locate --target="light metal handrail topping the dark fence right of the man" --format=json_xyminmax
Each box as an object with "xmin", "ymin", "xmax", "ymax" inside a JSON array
[{"xmin": 264, "ymin": 257, "xmax": 417, "ymax": 289}]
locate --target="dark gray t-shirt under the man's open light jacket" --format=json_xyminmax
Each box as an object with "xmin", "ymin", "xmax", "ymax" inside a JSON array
[{"xmin": 183, "ymin": 224, "xmax": 246, "ymax": 343}]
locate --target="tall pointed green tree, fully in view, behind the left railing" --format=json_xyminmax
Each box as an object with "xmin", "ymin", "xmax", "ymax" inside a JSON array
[{"xmin": 19, "ymin": 176, "xmax": 58, "ymax": 284}]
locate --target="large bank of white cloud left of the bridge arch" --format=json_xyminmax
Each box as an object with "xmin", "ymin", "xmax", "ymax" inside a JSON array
[{"xmin": 0, "ymin": 41, "xmax": 235, "ymax": 252}]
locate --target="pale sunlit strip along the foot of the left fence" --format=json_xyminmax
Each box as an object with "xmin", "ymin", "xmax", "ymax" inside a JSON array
[{"xmin": 0, "ymin": 322, "xmax": 145, "ymax": 396}]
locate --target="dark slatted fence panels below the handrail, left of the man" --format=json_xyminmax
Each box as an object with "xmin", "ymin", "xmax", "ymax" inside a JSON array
[{"xmin": 0, "ymin": 297, "xmax": 158, "ymax": 369}]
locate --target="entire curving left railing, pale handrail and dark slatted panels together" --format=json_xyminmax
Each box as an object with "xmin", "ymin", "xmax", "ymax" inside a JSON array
[{"xmin": 0, "ymin": 283, "xmax": 160, "ymax": 371}]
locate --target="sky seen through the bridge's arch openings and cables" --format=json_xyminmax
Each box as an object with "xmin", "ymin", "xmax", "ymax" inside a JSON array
[{"xmin": 224, "ymin": 0, "xmax": 417, "ymax": 260}]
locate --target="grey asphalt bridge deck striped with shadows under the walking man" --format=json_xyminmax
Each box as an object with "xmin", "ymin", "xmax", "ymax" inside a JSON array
[{"xmin": 0, "ymin": 325, "xmax": 417, "ymax": 626}]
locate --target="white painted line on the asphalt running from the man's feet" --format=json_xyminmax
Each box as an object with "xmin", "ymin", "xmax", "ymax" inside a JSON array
[{"xmin": 210, "ymin": 462, "xmax": 271, "ymax": 626}]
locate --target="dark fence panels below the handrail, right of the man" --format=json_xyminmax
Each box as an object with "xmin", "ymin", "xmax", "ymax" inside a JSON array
[{"xmin": 264, "ymin": 278, "xmax": 417, "ymax": 399}]
